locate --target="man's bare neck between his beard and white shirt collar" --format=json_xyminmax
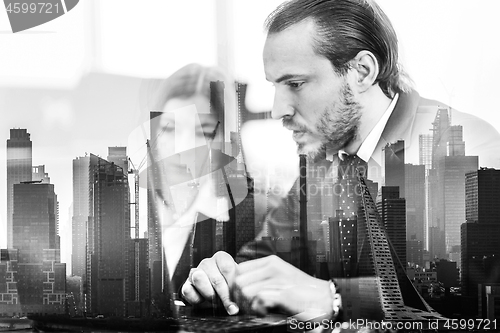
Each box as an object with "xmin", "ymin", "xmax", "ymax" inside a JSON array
[{"xmin": 343, "ymin": 84, "xmax": 392, "ymax": 155}]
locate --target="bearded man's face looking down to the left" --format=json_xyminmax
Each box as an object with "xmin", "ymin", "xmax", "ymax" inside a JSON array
[{"xmin": 264, "ymin": 20, "xmax": 361, "ymax": 157}]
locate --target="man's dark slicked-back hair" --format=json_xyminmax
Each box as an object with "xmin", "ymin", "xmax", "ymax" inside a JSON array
[{"xmin": 265, "ymin": 0, "xmax": 410, "ymax": 98}]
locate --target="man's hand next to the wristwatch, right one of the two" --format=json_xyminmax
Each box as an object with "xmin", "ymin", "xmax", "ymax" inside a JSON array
[{"xmin": 234, "ymin": 255, "xmax": 333, "ymax": 317}]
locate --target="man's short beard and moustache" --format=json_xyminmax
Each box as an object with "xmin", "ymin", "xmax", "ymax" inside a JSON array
[{"xmin": 283, "ymin": 82, "xmax": 361, "ymax": 161}]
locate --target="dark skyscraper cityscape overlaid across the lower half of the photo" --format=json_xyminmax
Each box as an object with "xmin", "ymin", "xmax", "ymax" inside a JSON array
[{"xmin": 0, "ymin": 78, "xmax": 500, "ymax": 326}]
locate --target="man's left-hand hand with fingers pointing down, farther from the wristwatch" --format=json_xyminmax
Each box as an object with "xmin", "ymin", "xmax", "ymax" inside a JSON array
[{"xmin": 181, "ymin": 251, "xmax": 239, "ymax": 315}]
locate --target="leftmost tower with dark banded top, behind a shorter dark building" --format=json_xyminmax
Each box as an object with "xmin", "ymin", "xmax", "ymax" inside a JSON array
[{"xmin": 7, "ymin": 128, "xmax": 32, "ymax": 248}]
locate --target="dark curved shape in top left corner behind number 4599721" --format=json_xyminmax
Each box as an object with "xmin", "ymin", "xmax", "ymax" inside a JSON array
[{"xmin": 3, "ymin": 0, "xmax": 79, "ymax": 33}]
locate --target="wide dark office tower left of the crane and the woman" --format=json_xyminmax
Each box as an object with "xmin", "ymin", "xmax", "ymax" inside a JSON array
[{"xmin": 72, "ymin": 149, "xmax": 133, "ymax": 315}]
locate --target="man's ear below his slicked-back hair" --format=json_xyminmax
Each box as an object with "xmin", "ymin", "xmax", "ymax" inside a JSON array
[{"xmin": 351, "ymin": 50, "xmax": 379, "ymax": 92}]
